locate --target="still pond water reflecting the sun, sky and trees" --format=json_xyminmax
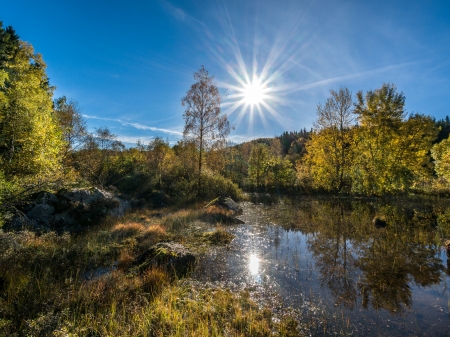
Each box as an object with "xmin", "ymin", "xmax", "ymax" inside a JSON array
[{"xmin": 194, "ymin": 198, "xmax": 450, "ymax": 336}]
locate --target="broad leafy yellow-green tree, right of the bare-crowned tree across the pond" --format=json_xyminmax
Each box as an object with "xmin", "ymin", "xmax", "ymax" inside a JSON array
[{"xmin": 352, "ymin": 84, "xmax": 437, "ymax": 195}]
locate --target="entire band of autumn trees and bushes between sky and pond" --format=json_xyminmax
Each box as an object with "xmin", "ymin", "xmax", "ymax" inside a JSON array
[{"xmin": 0, "ymin": 22, "xmax": 450, "ymax": 215}]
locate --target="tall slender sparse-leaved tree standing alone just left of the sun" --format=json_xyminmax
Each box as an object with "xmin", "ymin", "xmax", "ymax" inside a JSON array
[{"xmin": 181, "ymin": 66, "xmax": 231, "ymax": 193}]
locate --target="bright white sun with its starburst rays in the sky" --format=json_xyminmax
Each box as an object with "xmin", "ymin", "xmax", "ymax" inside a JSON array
[{"xmin": 208, "ymin": 9, "xmax": 299, "ymax": 133}]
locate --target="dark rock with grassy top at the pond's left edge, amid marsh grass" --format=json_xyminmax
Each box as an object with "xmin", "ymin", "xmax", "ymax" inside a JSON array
[{"xmin": 130, "ymin": 242, "xmax": 196, "ymax": 277}]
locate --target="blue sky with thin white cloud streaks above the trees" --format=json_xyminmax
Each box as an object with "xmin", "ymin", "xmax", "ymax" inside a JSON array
[{"xmin": 0, "ymin": 0, "xmax": 450, "ymax": 144}]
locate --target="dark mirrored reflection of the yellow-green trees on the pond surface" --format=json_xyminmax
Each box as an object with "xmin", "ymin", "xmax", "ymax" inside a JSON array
[{"xmin": 296, "ymin": 200, "xmax": 444, "ymax": 313}]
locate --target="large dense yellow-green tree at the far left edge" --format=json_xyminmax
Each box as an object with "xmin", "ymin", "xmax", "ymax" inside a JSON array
[{"xmin": 0, "ymin": 31, "xmax": 63, "ymax": 193}]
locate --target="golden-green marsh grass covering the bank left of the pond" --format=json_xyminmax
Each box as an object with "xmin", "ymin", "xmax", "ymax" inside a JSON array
[{"xmin": 0, "ymin": 206, "xmax": 312, "ymax": 336}]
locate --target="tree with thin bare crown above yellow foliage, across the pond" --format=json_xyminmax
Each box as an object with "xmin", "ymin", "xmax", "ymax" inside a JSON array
[{"xmin": 306, "ymin": 88, "xmax": 353, "ymax": 191}]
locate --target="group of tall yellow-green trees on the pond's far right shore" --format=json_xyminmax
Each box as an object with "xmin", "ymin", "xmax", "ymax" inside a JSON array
[{"xmin": 298, "ymin": 83, "xmax": 449, "ymax": 195}]
